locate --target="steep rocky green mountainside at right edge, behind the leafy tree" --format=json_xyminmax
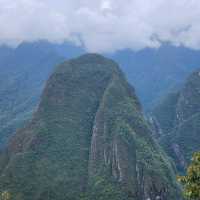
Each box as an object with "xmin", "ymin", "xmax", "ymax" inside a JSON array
[{"xmin": 153, "ymin": 70, "xmax": 200, "ymax": 171}]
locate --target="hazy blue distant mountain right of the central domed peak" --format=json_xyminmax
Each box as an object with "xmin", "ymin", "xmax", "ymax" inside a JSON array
[{"xmin": 111, "ymin": 44, "xmax": 200, "ymax": 111}]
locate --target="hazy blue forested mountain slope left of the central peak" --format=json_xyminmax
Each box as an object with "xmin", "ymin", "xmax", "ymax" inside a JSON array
[{"xmin": 0, "ymin": 41, "xmax": 83, "ymax": 148}]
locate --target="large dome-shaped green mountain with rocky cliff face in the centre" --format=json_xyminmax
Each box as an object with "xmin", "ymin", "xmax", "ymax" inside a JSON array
[{"xmin": 0, "ymin": 54, "xmax": 179, "ymax": 200}]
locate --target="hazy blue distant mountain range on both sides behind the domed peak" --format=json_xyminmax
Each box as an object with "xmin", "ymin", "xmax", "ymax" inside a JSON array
[{"xmin": 0, "ymin": 41, "xmax": 200, "ymax": 146}]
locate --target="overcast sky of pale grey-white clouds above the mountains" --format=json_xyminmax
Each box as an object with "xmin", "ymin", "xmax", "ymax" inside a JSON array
[{"xmin": 0, "ymin": 0, "xmax": 200, "ymax": 52}]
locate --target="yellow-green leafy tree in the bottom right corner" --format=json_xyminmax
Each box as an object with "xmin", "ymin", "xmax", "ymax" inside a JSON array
[{"xmin": 177, "ymin": 152, "xmax": 200, "ymax": 200}]
